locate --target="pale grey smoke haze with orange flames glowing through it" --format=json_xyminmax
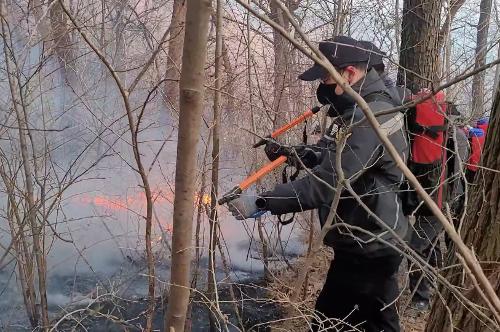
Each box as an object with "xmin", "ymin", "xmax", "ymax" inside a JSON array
[{"xmin": 0, "ymin": 17, "xmax": 302, "ymax": 326}]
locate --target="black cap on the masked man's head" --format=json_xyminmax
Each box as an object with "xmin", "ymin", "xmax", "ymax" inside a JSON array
[{"xmin": 299, "ymin": 36, "xmax": 370, "ymax": 81}]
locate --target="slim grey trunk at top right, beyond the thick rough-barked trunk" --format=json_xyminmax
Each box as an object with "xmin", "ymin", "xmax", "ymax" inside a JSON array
[{"xmin": 472, "ymin": 0, "xmax": 492, "ymax": 118}]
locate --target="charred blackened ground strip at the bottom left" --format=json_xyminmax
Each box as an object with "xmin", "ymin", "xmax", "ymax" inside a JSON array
[{"xmin": 52, "ymin": 284, "xmax": 283, "ymax": 332}]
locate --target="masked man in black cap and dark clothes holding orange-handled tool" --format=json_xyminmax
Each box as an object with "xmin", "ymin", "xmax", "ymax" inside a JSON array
[{"xmin": 229, "ymin": 36, "xmax": 409, "ymax": 332}]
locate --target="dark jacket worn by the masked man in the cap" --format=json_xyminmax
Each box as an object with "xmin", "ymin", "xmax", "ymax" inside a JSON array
[{"xmin": 262, "ymin": 70, "xmax": 409, "ymax": 257}]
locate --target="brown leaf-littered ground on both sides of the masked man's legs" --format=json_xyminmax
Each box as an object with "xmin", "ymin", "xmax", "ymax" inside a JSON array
[{"xmin": 271, "ymin": 248, "xmax": 428, "ymax": 332}]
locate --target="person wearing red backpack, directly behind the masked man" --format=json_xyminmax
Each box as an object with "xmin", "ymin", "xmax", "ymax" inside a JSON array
[{"xmin": 409, "ymin": 102, "xmax": 468, "ymax": 311}]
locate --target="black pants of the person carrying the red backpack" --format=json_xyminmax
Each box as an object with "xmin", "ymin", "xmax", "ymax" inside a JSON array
[{"xmin": 409, "ymin": 216, "xmax": 443, "ymax": 301}]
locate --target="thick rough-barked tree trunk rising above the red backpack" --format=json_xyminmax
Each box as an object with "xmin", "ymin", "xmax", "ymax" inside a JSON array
[{"xmin": 398, "ymin": 0, "xmax": 442, "ymax": 91}]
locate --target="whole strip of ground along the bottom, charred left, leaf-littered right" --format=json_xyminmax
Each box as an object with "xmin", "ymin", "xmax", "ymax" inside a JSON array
[{"xmin": 46, "ymin": 248, "xmax": 427, "ymax": 332}]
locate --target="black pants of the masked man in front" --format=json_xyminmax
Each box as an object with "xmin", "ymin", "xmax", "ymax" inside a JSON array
[{"xmin": 312, "ymin": 252, "xmax": 401, "ymax": 332}]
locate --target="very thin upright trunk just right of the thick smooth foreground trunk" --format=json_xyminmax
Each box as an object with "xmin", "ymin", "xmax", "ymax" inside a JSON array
[{"xmin": 208, "ymin": 0, "xmax": 223, "ymax": 332}]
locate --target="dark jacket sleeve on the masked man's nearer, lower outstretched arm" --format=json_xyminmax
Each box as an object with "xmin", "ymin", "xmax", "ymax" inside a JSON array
[{"xmin": 261, "ymin": 116, "xmax": 383, "ymax": 214}]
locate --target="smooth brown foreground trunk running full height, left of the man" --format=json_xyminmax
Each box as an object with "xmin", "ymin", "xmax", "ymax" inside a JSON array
[{"xmin": 164, "ymin": 0, "xmax": 211, "ymax": 332}]
